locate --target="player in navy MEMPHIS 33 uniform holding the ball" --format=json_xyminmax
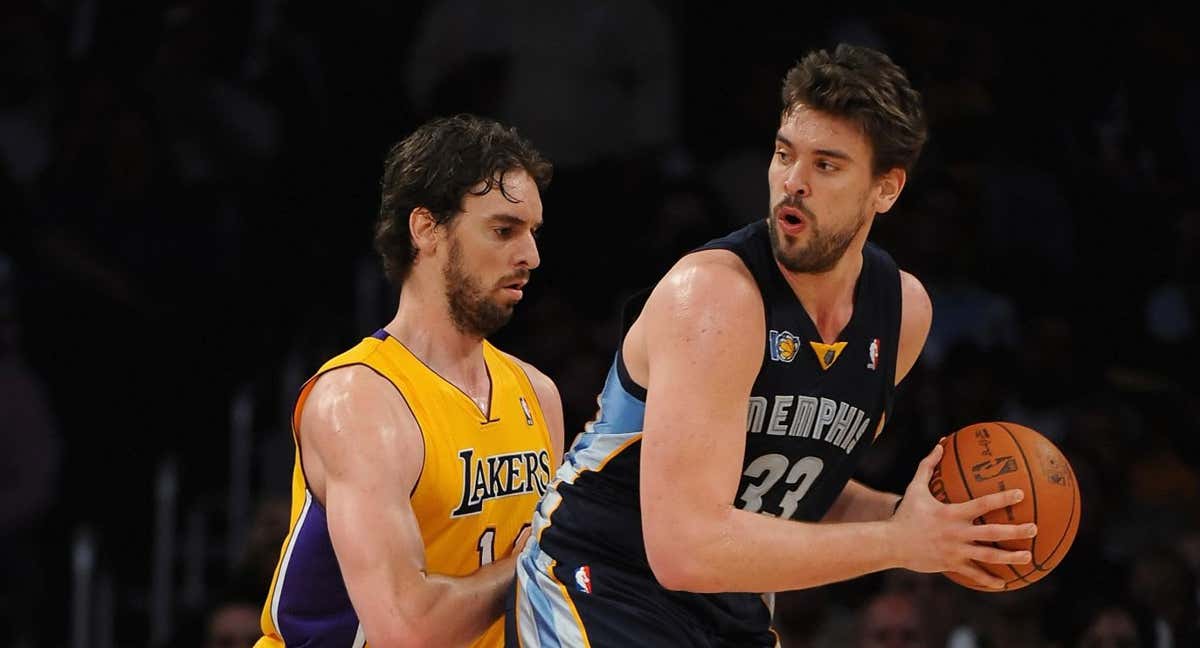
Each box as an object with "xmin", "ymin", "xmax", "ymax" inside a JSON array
[{"xmin": 506, "ymin": 46, "xmax": 1036, "ymax": 648}]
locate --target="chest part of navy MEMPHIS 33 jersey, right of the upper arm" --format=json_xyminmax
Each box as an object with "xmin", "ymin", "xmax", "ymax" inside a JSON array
[{"xmin": 704, "ymin": 222, "xmax": 900, "ymax": 521}]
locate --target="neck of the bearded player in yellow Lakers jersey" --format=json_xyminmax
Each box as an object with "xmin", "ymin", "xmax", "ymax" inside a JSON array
[{"xmin": 384, "ymin": 281, "xmax": 487, "ymax": 381}]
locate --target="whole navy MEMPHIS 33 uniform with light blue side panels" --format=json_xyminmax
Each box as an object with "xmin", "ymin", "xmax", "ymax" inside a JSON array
[{"xmin": 510, "ymin": 220, "xmax": 900, "ymax": 646}]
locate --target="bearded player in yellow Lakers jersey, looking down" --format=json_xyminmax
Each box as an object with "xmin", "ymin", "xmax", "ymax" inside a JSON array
[{"xmin": 257, "ymin": 115, "xmax": 563, "ymax": 648}]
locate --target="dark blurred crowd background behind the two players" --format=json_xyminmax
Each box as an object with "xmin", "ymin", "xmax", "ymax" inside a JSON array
[{"xmin": 0, "ymin": 0, "xmax": 1200, "ymax": 648}]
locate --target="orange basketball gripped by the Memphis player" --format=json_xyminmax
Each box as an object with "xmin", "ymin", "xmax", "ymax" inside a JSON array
[{"xmin": 929, "ymin": 421, "xmax": 1081, "ymax": 592}]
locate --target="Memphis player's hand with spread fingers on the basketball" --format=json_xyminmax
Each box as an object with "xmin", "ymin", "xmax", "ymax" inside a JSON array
[{"xmin": 888, "ymin": 444, "xmax": 1037, "ymax": 589}]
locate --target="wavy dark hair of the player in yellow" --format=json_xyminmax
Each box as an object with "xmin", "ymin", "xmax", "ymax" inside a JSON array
[{"xmin": 374, "ymin": 113, "xmax": 553, "ymax": 288}]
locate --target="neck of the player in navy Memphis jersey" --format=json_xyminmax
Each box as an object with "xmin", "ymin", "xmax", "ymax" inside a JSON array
[{"xmin": 780, "ymin": 236, "xmax": 865, "ymax": 343}]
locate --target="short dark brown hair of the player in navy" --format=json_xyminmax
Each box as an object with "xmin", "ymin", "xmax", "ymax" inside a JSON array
[{"xmin": 782, "ymin": 43, "xmax": 928, "ymax": 175}]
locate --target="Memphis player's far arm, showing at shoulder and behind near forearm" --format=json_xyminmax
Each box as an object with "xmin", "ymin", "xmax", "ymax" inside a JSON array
[{"xmin": 822, "ymin": 270, "xmax": 934, "ymax": 522}]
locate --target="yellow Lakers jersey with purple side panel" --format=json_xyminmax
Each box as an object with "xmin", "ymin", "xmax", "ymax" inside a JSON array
[{"xmin": 256, "ymin": 330, "xmax": 554, "ymax": 648}]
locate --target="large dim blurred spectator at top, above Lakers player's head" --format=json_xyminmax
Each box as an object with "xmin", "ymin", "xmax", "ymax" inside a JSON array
[{"xmin": 407, "ymin": 0, "xmax": 680, "ymax": 168}]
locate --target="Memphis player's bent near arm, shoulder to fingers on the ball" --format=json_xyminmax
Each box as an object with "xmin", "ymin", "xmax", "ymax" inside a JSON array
[{"xmin": 626, "ymin": 254, "xmax": 1027, "ymax": 592}]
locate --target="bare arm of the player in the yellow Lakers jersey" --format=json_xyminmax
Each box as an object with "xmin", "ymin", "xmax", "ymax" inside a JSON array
[{"xmin": 300, "ymin": 366, "xmax": 515, "ymax": 648}]
